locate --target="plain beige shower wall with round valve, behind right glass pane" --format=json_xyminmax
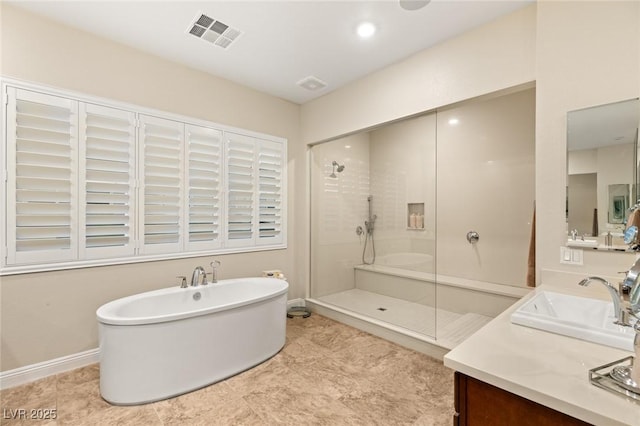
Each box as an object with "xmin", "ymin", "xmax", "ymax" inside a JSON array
[{"xmin": 436, "ymin": 89, "xmax": 536, "ymax": 287}]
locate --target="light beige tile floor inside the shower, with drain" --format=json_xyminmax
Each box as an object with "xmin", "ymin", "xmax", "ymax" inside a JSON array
[{"xmin": 318, "ymin": 288, "xmax": 492, "ymax": 349}]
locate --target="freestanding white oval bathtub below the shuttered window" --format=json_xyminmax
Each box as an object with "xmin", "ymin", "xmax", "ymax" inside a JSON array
[{"xmin": 97, "ymin": 278, "xmax": 289, "ymax": 405}]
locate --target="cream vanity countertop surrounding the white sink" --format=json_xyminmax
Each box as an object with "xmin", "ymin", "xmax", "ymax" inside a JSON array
[{"xmin": 444, "ymin": 285, "xmax": 640, "ymax": 426}]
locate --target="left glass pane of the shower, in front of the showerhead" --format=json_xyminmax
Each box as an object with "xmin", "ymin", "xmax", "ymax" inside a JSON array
[{"xmin": 311, "ymin": 114, "xmax": 436, "ymax": 338}]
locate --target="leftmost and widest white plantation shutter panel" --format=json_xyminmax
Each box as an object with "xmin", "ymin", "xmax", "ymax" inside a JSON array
[{"xmin": 6, "ymin": 87, "xmax": 78, "ymax": 264}]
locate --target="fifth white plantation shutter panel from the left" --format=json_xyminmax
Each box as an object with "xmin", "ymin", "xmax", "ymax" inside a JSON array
[{"xmin": 226, "ymin": 133, "xmax": 257, "ymax": 247}]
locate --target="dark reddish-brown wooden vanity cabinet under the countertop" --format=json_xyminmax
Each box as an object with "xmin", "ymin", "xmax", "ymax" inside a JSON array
[{"xmin": 453, "ymin": 371, "xmax": 589, "ymax": 426}]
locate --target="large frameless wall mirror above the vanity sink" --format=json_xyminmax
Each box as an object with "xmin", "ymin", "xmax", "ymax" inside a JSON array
[{"xmin": 567, "ymin": 99, "xmax": 640, "ymax": 251}]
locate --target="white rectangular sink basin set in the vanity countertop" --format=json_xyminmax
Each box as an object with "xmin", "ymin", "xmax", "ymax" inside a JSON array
[{"xmin": 511, "ymin": 291, "xmax": 635, "ymax": 351}]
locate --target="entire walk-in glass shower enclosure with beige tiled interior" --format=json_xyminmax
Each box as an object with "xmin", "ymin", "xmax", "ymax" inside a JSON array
[{"xmin": 310, "ymin": 88, "xmax": 535, "ymax": 348}]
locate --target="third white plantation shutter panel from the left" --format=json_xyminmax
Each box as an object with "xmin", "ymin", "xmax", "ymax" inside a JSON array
[{"xmin": 139, "ymin": 115, "xmax": 184, "ymax": 254}]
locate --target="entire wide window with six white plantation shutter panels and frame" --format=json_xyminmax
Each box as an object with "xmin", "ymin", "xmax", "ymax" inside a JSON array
[{"xmin": 0, "ymin": 79, "xmax": 287, "ymax": 276}]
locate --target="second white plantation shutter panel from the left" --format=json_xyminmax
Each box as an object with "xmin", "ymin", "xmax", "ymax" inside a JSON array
[{"xmin": 80, "ymin": 104, "xmax": 136, "ymax": 258}]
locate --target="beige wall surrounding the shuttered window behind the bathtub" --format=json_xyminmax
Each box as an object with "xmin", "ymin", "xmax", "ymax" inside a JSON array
[{"xmin": 0, "ymin": 3, "xmax": 307, "ymax": 371}]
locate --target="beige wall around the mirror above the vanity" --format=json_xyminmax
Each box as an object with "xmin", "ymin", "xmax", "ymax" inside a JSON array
[{"xmin": 536, "ymin": 1, "xmax": 640, "ymax": 287}]
